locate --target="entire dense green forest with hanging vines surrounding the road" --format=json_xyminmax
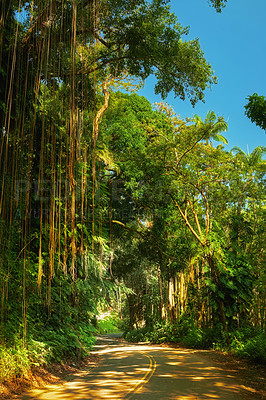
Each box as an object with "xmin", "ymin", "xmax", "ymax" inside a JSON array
[{"xmin": 0, "ymin": 0, "xmax": 266, "ymax": 382}]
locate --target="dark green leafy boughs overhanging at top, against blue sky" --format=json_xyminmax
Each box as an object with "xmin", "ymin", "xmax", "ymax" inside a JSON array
[{"xmin": 99, "ymin": 0, "xmax": 216, "ymax": 104}]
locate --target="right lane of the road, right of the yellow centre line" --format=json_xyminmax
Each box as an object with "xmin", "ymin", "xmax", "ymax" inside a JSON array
[{"xmin": 124, "ymin": 346, "xmax": 240, "ymax": 400}]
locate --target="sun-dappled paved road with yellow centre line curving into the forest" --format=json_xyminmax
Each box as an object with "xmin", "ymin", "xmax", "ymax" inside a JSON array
[{"xmin": 21, "ymin": 335, "xmax": 242, "ymax": 400}]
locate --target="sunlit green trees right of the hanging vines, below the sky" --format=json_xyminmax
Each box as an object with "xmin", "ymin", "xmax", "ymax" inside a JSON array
[{"xmin": 104, "ymin": 93, "xmax": 264, "ymax": 345}]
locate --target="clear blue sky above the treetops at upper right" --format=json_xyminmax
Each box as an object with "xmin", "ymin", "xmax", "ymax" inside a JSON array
[{"xmin": 139, "ymin": 0, "xmax": 266, "ymax": 152}]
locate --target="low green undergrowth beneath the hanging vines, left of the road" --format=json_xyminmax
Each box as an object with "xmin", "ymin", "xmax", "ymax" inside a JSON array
[{"xmin": 1, "ymin": 247, "xmax": 102, "ymax": 379}]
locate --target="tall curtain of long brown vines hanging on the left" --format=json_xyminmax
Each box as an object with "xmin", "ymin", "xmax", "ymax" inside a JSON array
[{"xmin": 0, "ymin": 0, "xmax": 108, "ymax": 344}]
